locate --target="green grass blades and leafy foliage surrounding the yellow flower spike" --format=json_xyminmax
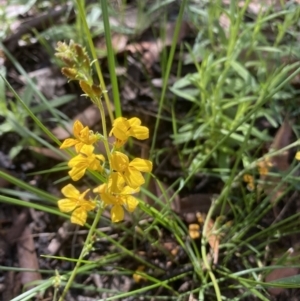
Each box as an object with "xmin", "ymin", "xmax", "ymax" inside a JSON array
[{"xmin": 0, "ymin": 0, "xmax": 300, "ymax": 301}]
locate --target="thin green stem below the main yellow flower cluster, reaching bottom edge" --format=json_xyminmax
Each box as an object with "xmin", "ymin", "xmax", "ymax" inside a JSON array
[{"xmin": 58, "ymin": 209, "xmax": 102, "ymax": 301}]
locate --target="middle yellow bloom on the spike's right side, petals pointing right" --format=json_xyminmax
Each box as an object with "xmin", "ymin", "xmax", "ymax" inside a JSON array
[{"xmin": 110, "ymin": 152, "xmax": 152, "ymax": 188}]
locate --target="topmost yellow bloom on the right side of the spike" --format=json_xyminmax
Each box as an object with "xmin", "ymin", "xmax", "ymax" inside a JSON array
[{"xmin": 109, "ymin": 117, "xmax": 149, "ymax": 148}]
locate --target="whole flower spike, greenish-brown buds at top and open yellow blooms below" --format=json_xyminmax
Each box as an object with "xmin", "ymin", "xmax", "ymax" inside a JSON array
[{"xmin": 56, "ymin": 41, "xmax": 152, "ymax": 225}]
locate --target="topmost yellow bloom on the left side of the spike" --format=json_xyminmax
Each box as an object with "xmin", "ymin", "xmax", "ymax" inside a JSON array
[{"xmin": 60, "ymin": 120, "xmax": 98, "ymax": 153}]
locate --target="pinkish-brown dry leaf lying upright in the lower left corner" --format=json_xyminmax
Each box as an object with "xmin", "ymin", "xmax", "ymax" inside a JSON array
[{"xmin": 17, "ymin": 226, "xmax": 42, "ymax": 289}]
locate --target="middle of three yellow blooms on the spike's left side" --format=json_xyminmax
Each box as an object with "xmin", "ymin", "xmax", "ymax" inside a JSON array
[{"xmin": 68, "ymin": 144, "xmax": 105, "ymax": 181}]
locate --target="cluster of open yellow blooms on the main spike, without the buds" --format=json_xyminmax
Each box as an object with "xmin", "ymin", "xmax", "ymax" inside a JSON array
[{"xmin": 58, "ymin": 118, "xmax": 152, "ymax": 225}]
